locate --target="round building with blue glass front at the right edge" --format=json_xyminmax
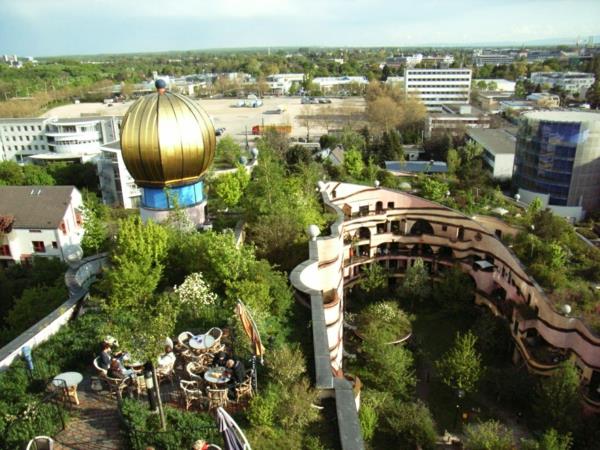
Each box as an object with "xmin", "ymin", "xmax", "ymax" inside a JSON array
[{"xmin": 513, "ymin": 111, "xmax": 600, "ymax": 220}]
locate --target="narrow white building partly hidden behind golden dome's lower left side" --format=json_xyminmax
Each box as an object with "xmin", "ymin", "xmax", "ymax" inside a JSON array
[{"xmin": 97, "ymin": 141, "xmax": 142, "ymax": 209}]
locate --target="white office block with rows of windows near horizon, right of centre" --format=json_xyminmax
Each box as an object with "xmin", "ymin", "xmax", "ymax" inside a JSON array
[{"xmin": 404, "ymin": 69, "xmax": 471, "ymax": 110}]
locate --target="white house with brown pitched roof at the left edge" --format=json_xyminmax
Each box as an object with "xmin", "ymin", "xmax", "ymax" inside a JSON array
[{"xmin": 0, "ymin": 186, "xmax": 84, "ymax": 266}]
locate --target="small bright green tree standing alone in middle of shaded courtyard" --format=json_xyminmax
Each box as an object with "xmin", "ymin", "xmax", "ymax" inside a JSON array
[{"xmin": 436, "ymin": 330, "xmax": 483, "ymax": 393}]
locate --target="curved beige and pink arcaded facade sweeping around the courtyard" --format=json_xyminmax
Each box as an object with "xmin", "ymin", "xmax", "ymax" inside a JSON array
[{"xmin": 290, "ymin": 182, "xmax": 600, "ymax": 407}]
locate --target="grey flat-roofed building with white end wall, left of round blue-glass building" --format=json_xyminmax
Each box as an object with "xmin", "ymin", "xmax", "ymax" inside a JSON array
[{"xmin": 467, "ymin": 128, "xmax": 517, "ymax": 180}]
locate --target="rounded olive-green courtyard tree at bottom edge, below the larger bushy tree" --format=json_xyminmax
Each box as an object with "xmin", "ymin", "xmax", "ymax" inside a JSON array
[{"xmin": 384, "ymin": 400, "xmax": 437, "ymax": 449}]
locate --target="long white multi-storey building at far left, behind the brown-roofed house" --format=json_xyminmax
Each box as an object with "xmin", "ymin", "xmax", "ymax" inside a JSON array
[{"xmin": 0, "ymin": 116, "xmax": 121, "ymax": 163}]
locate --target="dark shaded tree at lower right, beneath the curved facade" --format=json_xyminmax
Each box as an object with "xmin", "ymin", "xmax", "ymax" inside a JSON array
[{"xmin": 533, "ymin": 361, "xmax": 580, "ymax": 433}]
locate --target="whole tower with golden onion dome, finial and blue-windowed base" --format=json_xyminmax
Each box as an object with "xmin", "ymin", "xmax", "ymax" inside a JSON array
[{"xmin": 121, "ymin": 80, "xmax": 216, "ymax": 226}]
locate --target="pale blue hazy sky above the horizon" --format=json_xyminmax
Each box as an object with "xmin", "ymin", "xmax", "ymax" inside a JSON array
[{"xmin": 0, "ymin": 0, "xmax": 600, "ymax": 56}]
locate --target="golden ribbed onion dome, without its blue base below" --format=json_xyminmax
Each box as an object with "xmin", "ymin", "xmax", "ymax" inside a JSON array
[{"xmin": 121, "ymin": 89, "xmax": 216, "ymax": 187}]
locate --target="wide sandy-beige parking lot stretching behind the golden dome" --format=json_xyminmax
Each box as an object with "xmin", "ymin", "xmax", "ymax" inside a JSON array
[{"xmin": 43, "ymin": 97, "xmax": 365, "ymax": 142}]
